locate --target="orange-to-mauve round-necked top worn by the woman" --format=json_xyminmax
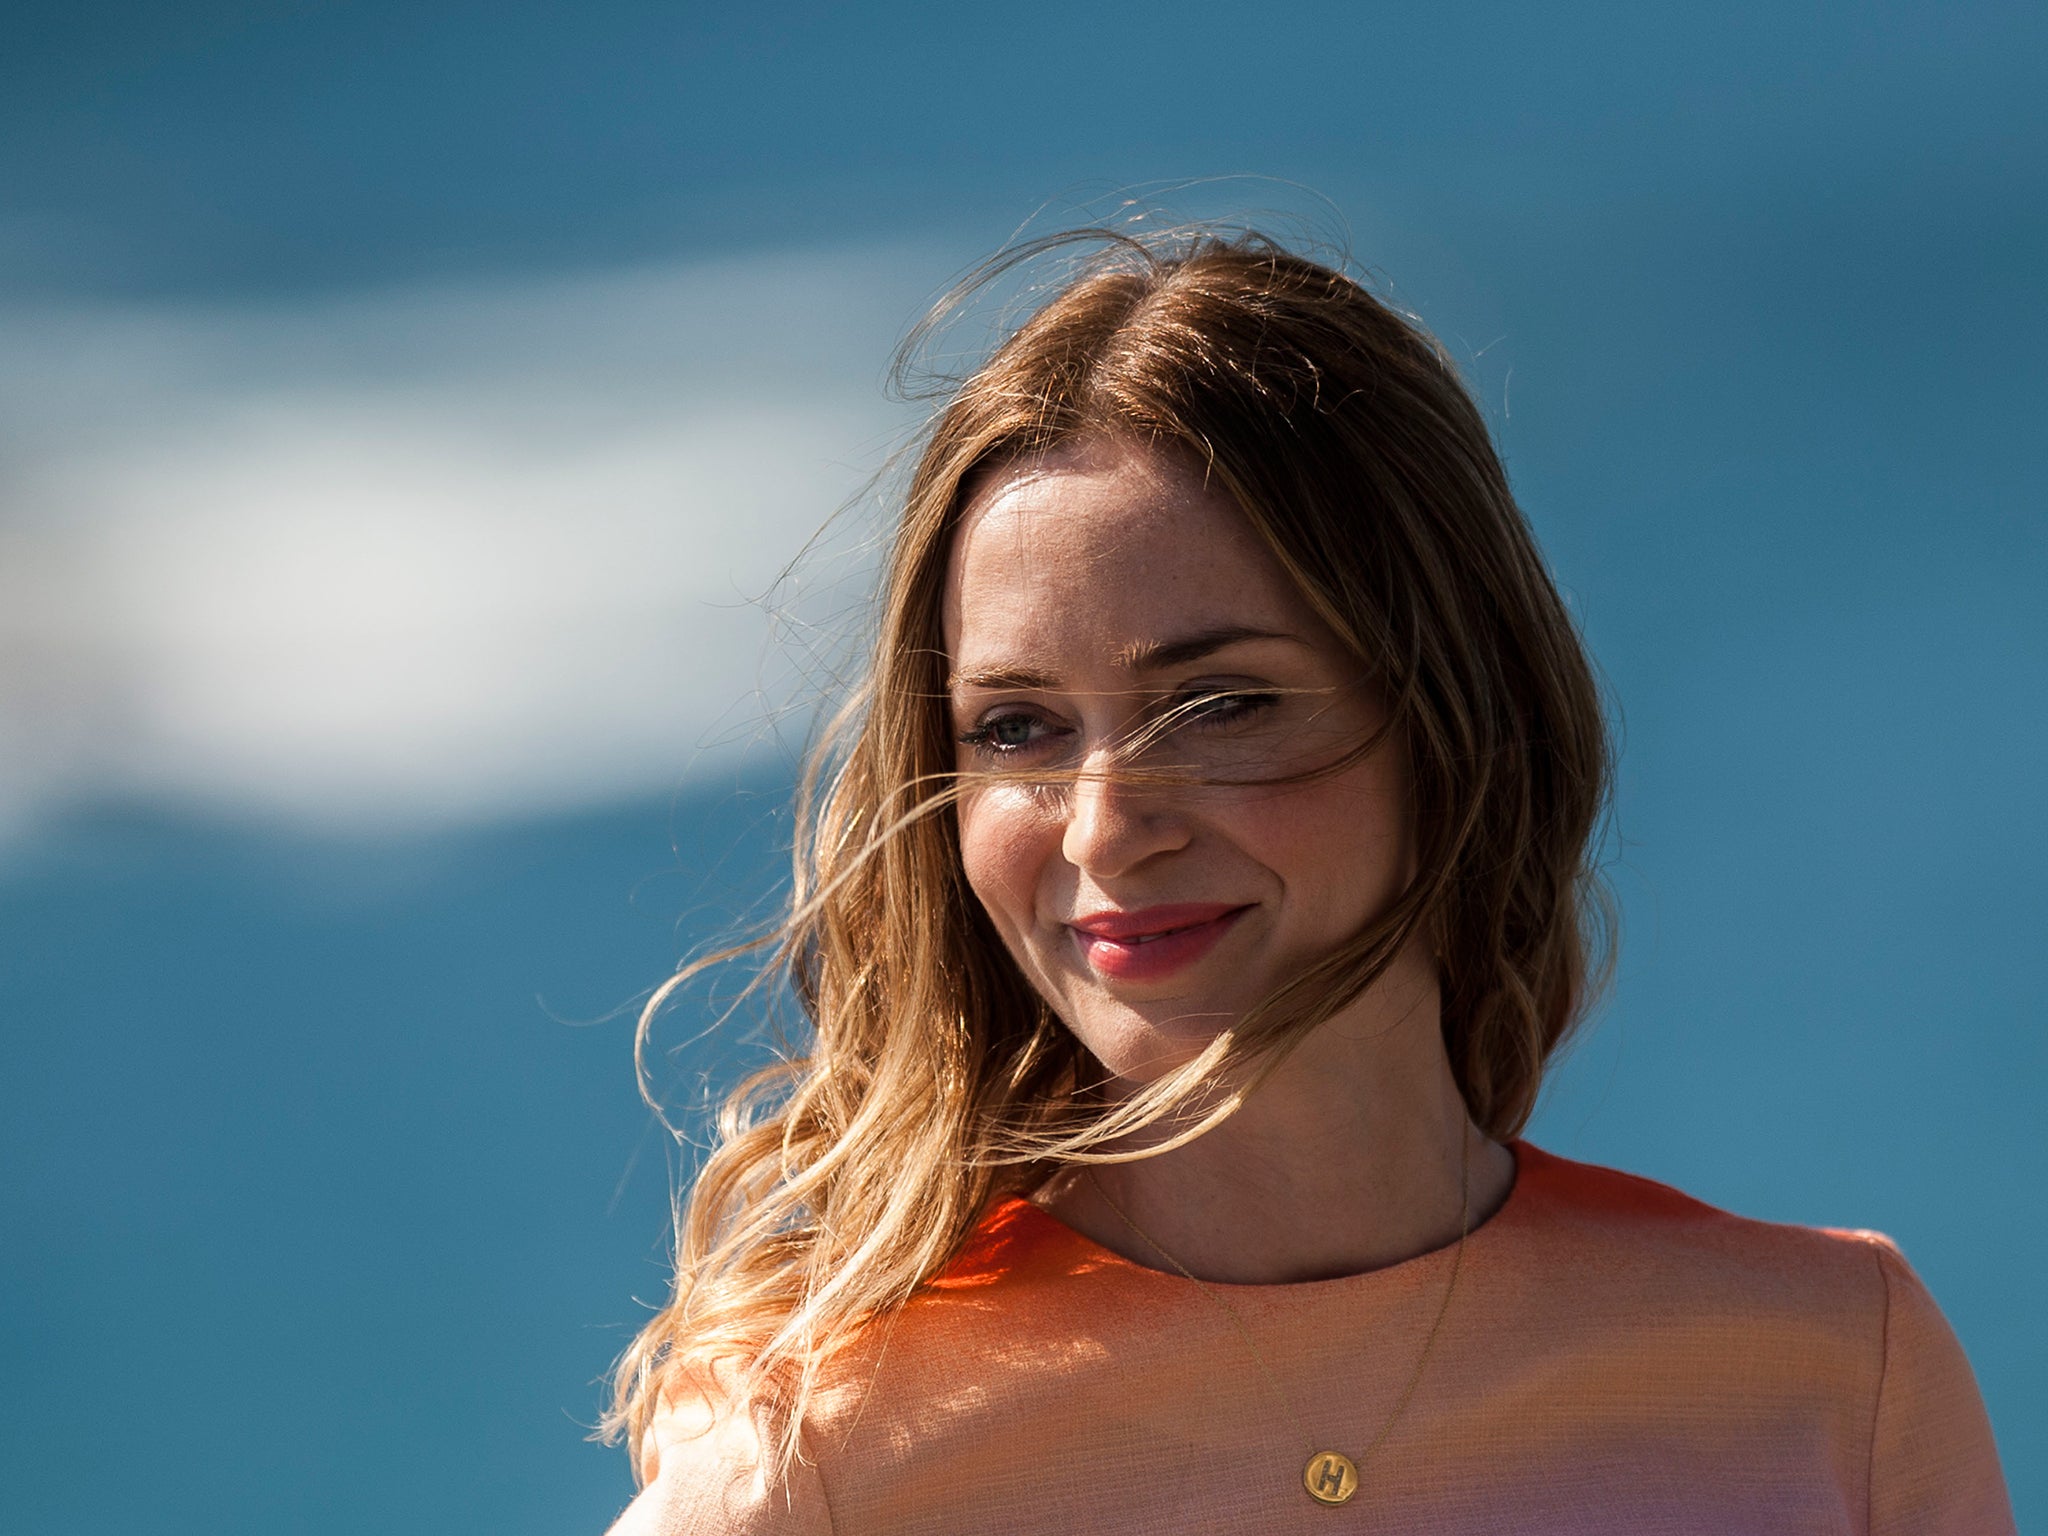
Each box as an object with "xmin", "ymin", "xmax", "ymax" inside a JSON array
[{"xmin": 614, "ymin": 1143, "xmax": 2013, "ymax": 1536}]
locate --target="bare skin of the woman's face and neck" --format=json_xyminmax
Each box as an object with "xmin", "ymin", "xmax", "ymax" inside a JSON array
[{"xmin": 944, "ymin": 438, "xmax": 1513, "ymax": 1284}]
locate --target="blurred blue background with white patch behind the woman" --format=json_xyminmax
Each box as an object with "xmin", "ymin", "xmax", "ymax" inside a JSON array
[{"xmin": 0, "ymin": 2, "xmax": 2048, "ymax": 1532}]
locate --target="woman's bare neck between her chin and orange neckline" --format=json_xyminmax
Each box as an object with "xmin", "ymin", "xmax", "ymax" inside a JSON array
[{"xmin": 1036, "ymin": 963, "xmax": 1513, "ymax": 1284}]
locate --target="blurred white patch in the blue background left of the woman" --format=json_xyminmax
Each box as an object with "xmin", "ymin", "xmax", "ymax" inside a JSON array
[{"xmin": 0, "ymin": 252, "xmax": 934, "ymax": 843}]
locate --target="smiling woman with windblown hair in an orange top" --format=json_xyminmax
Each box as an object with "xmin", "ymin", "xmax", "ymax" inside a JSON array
[{"xmin": 598, "ymin": 236, "xmax": 2011, "ymax": 1536}]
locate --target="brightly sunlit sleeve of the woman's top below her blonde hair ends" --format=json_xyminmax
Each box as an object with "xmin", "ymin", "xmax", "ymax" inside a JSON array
[{"xmin": 610, "ymin": 1401, "xmax": 831, "ymax": 1536}]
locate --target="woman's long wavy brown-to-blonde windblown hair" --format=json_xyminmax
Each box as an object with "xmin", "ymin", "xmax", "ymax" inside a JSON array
[{"xmin": 608, "ymin": 231, "xmax": 1610, "ymax": 1470}]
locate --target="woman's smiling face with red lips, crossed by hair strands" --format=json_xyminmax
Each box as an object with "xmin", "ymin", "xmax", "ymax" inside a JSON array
[{"xmin": 944, "ymin": 438, "xmax": 1411, "ymax": 1083}]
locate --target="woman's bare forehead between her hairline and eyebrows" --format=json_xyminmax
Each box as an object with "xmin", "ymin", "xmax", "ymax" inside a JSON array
[{"xmin": 944, "ymin": 438, "xmax": 1319, "ymax": 668}]
